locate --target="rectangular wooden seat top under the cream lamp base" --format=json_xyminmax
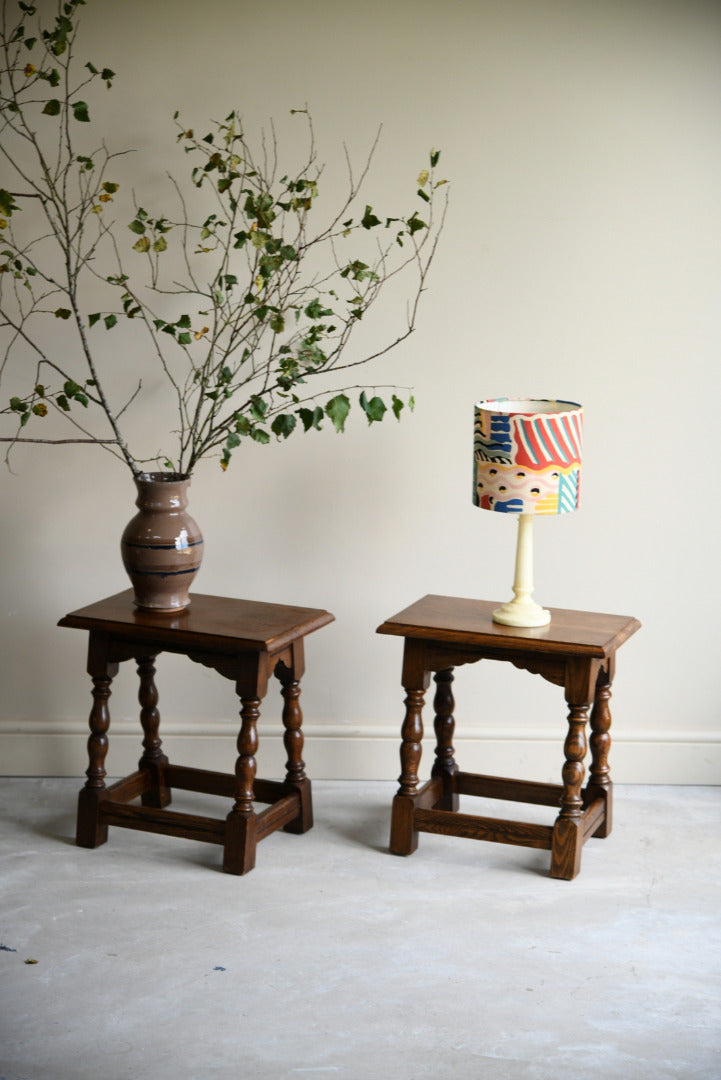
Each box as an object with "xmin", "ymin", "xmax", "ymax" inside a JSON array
[{"xmin": 377, "ymin": 594, "xmax": 641, "ymax": 659}]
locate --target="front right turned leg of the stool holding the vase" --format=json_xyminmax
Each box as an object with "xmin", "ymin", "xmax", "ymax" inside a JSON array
[{"xmin": 222, "ymin": 698, "xmax": 260, "ymax": 874}]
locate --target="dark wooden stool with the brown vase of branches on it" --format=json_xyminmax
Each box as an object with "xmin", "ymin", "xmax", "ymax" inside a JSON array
[{"xmin": 58, "ymin": 590, "xmax": 334, "ymax": 874}]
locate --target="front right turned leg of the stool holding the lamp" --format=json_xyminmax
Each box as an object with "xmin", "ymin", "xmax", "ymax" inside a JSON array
[{"xmin": 550, "ymin": 705, "xmax": 588, "ymax": 881}]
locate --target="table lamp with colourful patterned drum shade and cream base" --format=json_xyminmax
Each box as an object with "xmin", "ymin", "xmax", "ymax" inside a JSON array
[{"xmin": 473, "ymin": 397, "xmax": 583, "ymax": 626}]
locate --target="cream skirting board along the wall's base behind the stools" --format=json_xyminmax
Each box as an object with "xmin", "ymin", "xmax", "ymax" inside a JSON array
[{"xmin": 0, "ymin": 719, "xmax": 721, "ymax": 784}]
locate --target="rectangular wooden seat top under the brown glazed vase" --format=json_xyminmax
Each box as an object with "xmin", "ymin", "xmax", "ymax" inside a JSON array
[{"xmin": 58, "ymin": 589, "xmax": 334, "ymax": 652}]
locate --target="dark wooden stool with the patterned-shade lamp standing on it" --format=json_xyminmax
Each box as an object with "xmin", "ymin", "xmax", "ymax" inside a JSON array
[{"xmin": 378, "ymin": 596, "xmax": 641, "ymax": 880}]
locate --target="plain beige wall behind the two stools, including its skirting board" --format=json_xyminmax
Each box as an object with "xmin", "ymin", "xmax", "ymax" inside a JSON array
[{"xmin": 0, "ymin": 0, "xmax": 721, "ymax": 783}]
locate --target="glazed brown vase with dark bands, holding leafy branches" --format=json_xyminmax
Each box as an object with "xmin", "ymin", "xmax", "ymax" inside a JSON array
[{"xmin": 121, "ymin": 473, "xmax": 203, "ymax": 611}]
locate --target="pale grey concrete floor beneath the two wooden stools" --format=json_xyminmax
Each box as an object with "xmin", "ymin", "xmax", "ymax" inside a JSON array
[{"xmin": 0, "ymin": 779, "xmax": 721, "ymax": 1080}]
